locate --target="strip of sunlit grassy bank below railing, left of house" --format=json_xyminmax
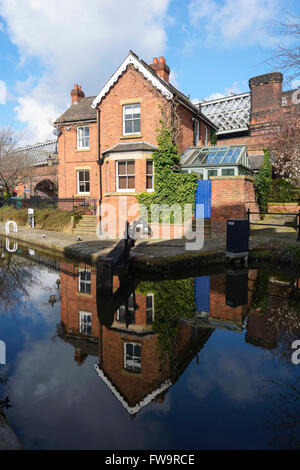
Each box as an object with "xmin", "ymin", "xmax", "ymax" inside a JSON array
[{"xmin": 0, "ymin": 206, "xmax": 81, "ymax": 232}]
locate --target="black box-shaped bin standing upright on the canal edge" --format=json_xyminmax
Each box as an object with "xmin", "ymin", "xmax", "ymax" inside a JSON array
[{"xmin": 226, "ymin": 219, "xmax": 250, "ymax": 254}]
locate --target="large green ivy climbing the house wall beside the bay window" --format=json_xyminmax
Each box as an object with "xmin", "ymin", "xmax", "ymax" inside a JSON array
[{"xmin": 137, "ymin": 114, "xmax": 198, "ymax": 222}]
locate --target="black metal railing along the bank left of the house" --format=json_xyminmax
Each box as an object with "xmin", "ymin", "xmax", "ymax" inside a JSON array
[{"xmin": 3, "ymin": 197, "xmax": 97, "ymax": 215}]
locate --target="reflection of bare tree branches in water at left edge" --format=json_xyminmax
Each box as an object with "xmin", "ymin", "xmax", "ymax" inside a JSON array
[{"xmin": 0, "ymin": 248, "xmax": 38, "ymax": 313}]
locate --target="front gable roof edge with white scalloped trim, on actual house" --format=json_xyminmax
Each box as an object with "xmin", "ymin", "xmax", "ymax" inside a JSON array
[{"xmin": 92, "ymin": 51, "xmax": 217, "ymax": 129}]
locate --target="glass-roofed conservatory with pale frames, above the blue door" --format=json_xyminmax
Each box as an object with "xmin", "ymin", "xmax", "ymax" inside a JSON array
[{"xmin": 180, "ymin": 145, "xmax": 252, "ymax": 180}]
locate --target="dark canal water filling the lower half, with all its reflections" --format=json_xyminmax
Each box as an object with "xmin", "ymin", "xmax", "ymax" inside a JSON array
[{"xmin": 0, "ymin": 243, "xmax": 300, "ymax": 450}]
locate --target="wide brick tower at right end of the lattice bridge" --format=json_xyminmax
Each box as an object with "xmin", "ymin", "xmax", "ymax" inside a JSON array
[{"xmin": 249, "ymin": 72, "xmax": 283, "ymax": 125}]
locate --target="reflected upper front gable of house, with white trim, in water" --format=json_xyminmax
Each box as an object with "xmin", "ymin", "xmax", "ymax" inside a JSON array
[{"xmin": 95, "ymin": 323, "xmax": 212, "ymax": 415}]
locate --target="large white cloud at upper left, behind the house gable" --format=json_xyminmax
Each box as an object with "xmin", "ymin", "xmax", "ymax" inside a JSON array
[{"xmin": 0, "ymin": 0, "xmax": 170, "ymax": 140}]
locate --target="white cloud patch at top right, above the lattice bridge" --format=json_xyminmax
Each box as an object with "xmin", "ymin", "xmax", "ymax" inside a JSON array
[{"xmin": 186, "ymin": 0, "xmax": 282, "ymax": 47}]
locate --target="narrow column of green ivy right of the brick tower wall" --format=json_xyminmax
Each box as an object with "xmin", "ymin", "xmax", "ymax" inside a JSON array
[{"xmin": 254, "ymin": 149, "xmax": 272, "ymax": 213}]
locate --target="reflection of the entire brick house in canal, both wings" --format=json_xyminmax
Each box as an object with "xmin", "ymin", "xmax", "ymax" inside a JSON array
[{"xmin": 58, "ymin": 263, "xmax": 212, "ymax": 415}]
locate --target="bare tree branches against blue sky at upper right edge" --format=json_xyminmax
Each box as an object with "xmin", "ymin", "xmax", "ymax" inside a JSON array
[{"xmin": 266, "ymin": 14, "xmax": 300, "ymax": 82}]
